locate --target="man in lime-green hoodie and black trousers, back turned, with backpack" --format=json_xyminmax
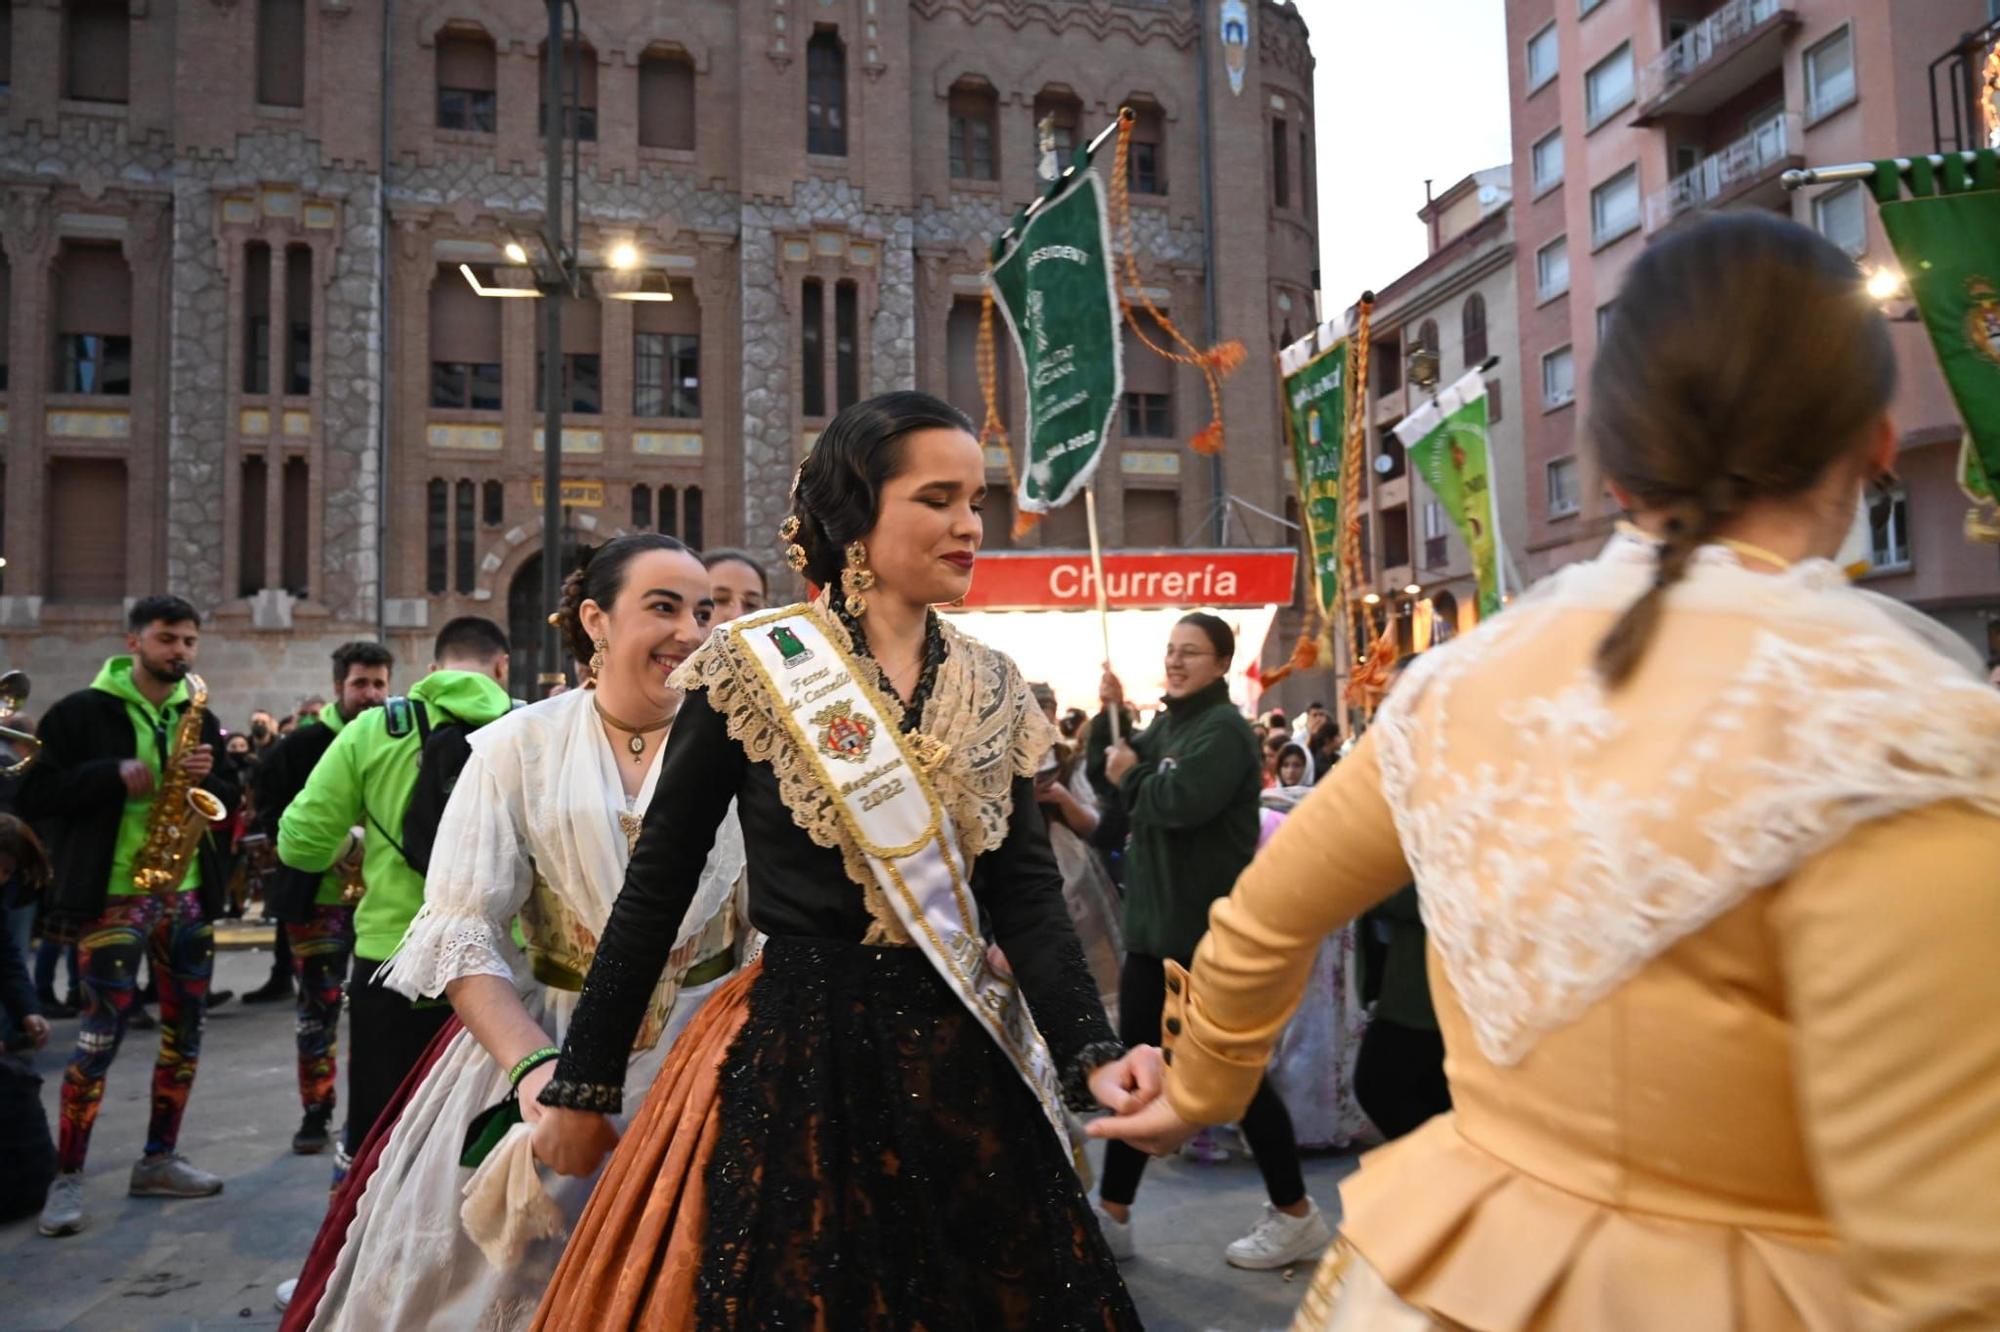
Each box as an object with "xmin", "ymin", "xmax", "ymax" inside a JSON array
[{"xmin": 278, "ymin": 616, "xmax": 514, "ymax": 1182}]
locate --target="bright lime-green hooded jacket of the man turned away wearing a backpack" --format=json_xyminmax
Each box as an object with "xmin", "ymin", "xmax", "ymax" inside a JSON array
[{"xmin": 278, "ymin": 670, "xmax": 514, "ymax": 962}]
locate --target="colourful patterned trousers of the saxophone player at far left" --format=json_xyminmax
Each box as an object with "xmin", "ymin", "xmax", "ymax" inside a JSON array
[{"xmin": 56, "ymin": 892, "xmax": 216, "ymax": 1172}]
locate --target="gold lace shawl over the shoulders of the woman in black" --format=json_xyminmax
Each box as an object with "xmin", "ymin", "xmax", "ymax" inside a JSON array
[{"xmin": 672, "ymin": 596, "xmax": 1056, "ymax": 908}]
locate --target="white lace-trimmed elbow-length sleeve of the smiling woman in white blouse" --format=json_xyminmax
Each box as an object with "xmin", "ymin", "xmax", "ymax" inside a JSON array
[{"xmin": 382, "ymin": 752, "xmax": 534, "ymax": 998}]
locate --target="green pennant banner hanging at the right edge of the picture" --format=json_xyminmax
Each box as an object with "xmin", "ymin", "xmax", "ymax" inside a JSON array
[{"xmin": 1874, "ymin": 150, "xmax": 2000, "ymax": 498}]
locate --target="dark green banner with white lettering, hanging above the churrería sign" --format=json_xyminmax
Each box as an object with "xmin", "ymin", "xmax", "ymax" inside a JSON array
[{"xmin": 988, "ymin": 170, "xmax": 1124, "ymax": 514}]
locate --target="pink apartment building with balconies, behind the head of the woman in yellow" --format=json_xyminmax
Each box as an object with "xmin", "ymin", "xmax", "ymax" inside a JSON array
[{"xmin": 1506, "ymin": 0, "xmax": 2000, "ymax": 650}]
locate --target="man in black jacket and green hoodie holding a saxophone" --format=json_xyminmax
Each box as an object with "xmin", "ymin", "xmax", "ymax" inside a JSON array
[{"xmin": 20, "ymin": 596, "xmax": 238, "ymax": 1236}]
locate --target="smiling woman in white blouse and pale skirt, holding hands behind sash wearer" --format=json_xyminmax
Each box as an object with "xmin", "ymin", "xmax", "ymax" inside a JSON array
[{"xmin": 310, "ymin": 534, "xmax": 746, "ymax": 1332}]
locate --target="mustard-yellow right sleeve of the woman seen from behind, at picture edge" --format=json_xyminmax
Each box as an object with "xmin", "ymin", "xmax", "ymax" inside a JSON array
[{"xmin": 1772, "ymin": 802, "xmax": 2000, "ymax": 1332}]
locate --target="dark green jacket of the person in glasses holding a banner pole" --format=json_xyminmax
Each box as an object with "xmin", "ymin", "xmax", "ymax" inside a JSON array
[{"xmin": 1090, "ymin": 680, "xmax": 1264, "ymax": 962}]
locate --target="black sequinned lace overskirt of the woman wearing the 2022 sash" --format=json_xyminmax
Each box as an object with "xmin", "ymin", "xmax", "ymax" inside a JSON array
[{"xmin": 698, "ymin": 938, "xmax": 1142, "ymax": 1332}]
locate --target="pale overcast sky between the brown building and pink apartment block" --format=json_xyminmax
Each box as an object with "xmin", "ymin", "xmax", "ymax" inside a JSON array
[{"xmin": 1288, "ymin": 0, "xmax": 1512, "ymax": 316}]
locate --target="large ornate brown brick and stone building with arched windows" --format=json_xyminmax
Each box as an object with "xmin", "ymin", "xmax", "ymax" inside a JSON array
[{"xmin": 0, "ymin": 0, "xmax": 1318, "ymax": 718}]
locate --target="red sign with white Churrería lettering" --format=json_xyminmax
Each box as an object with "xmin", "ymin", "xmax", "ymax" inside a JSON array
[{"xmin": 964, "ymin": 550, "xmax": 1298, "ymax": 610}]
